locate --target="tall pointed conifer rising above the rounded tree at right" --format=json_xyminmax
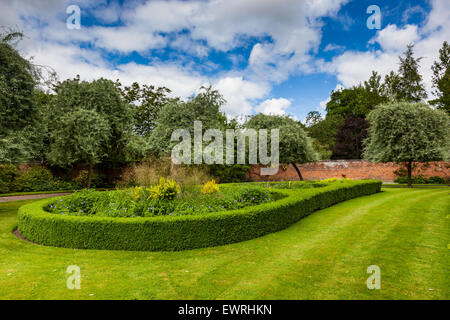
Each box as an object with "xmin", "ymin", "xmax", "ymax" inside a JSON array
[{"xmin": 395, "ymin": 44, "xmax": 427, "ymax": 102}]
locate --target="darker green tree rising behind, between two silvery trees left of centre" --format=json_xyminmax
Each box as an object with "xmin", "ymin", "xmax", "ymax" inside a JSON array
[{"xmin": 117, "ymin": 82, "xmax": 172, "ymax": 137}]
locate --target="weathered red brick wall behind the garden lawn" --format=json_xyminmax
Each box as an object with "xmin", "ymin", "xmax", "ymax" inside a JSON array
[{"xmin": 249, "ymin": 160, "xmax": 450, "ymax": 182}]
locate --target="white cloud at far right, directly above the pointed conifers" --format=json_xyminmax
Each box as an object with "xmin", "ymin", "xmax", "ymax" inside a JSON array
[{"xmin": 324, "ymin": 0, "xmax": 450, "ymax": 97}]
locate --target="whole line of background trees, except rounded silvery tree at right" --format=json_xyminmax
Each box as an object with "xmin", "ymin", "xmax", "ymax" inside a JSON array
[{"xmin": 0, "ymin": 32, "xmax": 450, "ymax": 185}]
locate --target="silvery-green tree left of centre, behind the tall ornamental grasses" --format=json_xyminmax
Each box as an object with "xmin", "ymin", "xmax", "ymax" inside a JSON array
[{"xmin": 149, "ymin": 87, "xmax": 227, "ymax": 157}]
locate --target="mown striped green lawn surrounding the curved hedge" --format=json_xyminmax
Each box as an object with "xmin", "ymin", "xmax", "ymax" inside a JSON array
[{"xmin": 0, "ymin": 188, "xmax": 450, "ymax": 299}]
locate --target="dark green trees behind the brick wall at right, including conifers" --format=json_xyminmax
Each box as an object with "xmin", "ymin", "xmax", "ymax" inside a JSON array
[{"xmin": 305, "ymin": 42, "xmax": 450, "ymax": 159}]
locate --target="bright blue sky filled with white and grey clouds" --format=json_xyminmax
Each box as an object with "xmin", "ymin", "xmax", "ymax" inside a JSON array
[{"xmin": 0, "ymin": 0, "xmax": 450, "ymax": 120}]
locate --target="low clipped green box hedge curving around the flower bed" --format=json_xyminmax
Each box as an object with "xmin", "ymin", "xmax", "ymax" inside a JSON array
[{"xmin": 18, "ymin": 180, "xmax": 381, "ymax": 251}]
